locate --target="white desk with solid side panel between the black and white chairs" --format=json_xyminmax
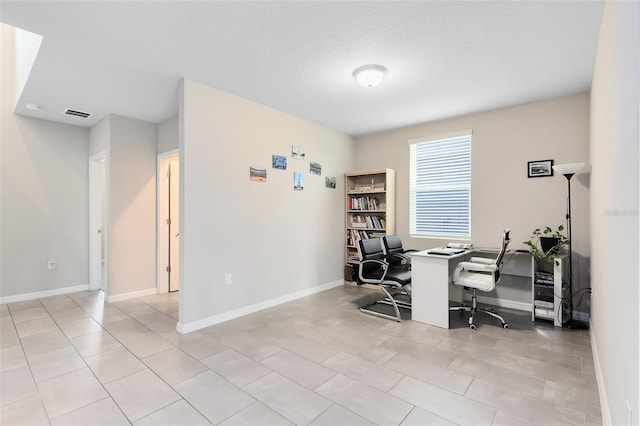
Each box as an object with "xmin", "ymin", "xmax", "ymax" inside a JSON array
[{"xmin": 407, "ymin": 250, "xmax": 473, "ymax": 328}]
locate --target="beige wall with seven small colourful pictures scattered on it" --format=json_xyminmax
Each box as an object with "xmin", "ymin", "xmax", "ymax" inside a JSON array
[{"xmin": 180, "ymin": 80, "xmax": 354, "ymax": 330}]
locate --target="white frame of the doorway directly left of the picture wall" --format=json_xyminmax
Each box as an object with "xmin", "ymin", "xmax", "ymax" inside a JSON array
[{"xmin": 156, "ymin": 149, "xmax": 180, "ymax": 293}]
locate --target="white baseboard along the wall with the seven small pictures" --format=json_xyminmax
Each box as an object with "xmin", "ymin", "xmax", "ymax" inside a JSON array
[{"xmin": 176, "ymin": 280, "xmax": 344, "ymax": 334}]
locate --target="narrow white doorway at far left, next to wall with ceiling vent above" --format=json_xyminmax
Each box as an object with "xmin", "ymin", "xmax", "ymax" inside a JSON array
[{"xmin": 89, "ymin": 151, "xmax": 108, "ymax": 291}]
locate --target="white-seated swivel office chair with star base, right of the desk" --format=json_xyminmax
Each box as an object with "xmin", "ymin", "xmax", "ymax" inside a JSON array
[{"xmin": 449, "ymin": 229, "xmax": 511, "ymax": 330}]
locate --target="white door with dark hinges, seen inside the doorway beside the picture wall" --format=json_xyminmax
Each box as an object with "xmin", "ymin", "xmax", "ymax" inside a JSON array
[{"xmin": 167, "ymin": 156, "xmax": 180, "ymax": 291}]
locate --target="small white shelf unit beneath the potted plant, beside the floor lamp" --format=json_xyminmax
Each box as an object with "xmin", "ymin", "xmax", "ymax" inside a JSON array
[{"xmin": 531, "ymin": 255, "xmax": 568, "ymax": 327}]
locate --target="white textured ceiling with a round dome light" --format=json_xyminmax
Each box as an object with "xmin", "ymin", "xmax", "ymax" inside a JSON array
[{"xmin": 0, "ymin": 0, "xmax": 603, "ymax": 135}]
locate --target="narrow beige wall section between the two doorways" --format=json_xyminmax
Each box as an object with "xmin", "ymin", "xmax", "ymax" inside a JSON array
[{"xmin": 107, "ymin": 114, "xmax": 157, "ymax": 300}]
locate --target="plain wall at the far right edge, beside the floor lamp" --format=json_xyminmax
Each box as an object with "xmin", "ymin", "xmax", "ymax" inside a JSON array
[{"xmin": 591, "ymin": 1, "xmax": 640, "ymax": 425}]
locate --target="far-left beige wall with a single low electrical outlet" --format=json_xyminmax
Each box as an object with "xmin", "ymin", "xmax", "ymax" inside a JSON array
[{"xmin": 0, "ymin": 25, "xmax": 89, "ymax": 301}]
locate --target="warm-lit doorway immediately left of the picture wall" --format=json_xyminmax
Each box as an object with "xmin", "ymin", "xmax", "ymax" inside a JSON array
[{"xmin": 158, "ymin": 150, "xmax": 180, "ymax": 293}]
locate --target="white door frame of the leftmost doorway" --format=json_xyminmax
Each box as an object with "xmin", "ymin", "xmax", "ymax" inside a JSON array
[{"xmin": 89, "ymin": 151, "xmax": 109, "ymax": 292}]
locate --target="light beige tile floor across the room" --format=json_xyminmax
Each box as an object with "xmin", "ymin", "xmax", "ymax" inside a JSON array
[{"xmin": 0, "ymin": 286, "xmax": 602, "ymax": 426}]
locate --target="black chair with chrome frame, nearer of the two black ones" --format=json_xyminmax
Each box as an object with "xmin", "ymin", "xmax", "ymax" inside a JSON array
[{"xmin": 358, "ymin": 238, "xmax": 411, "ymax": 322}]
